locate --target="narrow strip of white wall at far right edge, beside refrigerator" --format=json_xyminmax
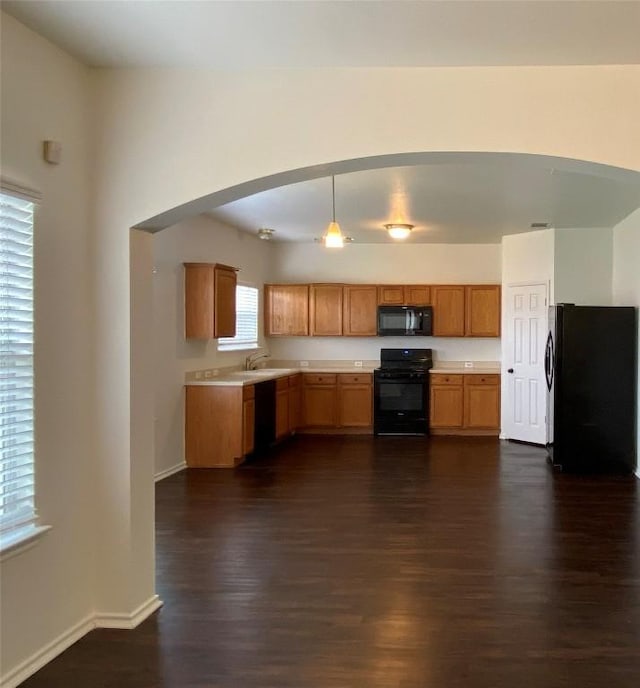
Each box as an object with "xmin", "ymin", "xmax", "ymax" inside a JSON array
[{"xmin": 613, "ymin": 209, "xmax": 640, "ymax": 470}]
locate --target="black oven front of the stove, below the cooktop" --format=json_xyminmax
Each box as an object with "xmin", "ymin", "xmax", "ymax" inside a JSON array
[{"xmin": 373, "ymin": 371, "xmax": 429, "ymax": 435}]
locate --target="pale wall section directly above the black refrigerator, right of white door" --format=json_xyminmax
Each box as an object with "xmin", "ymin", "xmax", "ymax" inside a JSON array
[{"xmin": 554, "ymin": 227, "xmax": 613, "ymax": 306}]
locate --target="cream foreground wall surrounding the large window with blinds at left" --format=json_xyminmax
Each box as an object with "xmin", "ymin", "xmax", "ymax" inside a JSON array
[{"xmin": 0, "ymin": 14, "xmax": 97, "ymax": 685}]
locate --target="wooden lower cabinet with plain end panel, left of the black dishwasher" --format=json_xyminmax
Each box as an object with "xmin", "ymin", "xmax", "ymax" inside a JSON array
[{"xmin": 185, "ymin": 385, "xmax": 255, "ymax": 468}]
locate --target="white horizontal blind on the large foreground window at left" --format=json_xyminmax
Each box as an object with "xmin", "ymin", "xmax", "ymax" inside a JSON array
[{"xmin": 0, "ymin": 193, "xmax": 35, "ymax": 540}]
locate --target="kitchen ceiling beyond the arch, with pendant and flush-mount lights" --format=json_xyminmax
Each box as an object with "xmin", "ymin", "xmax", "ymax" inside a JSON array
[{"xmin": 210, "ymin": 159, "xmax": 640, "ymax": 243}]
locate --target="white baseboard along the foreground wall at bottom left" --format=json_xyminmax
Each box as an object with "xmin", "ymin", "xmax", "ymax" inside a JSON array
[{"xmin": 0, "ymin": 595, "xmax": 162, "ymax": 688}]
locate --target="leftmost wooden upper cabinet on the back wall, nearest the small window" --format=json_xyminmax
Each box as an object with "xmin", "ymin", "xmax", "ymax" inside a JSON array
[{"xmin": 264, "ymin": 284, "xmax": 309, "ymax": 337}]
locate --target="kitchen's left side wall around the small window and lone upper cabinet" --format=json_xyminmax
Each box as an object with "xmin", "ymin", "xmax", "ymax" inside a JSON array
[{"xmin": 153, "ymin": 215, "xmax": 274, "ymax": 475}]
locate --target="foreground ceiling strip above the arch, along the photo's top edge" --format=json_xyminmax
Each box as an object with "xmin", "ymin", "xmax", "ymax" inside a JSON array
[{"xmin": 2, "ymin": 0, "xmax": 640, "ymax": 69}]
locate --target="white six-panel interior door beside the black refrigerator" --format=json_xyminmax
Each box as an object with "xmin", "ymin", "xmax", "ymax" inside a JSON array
[{"xmin": 502, "ymin": 284, "xmax": 548, "ymax": 444}]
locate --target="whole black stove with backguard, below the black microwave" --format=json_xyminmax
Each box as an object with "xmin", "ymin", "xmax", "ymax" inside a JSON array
[{"xmin": 373, "ymin": 349, "xmax": 433, "ymax": 435}]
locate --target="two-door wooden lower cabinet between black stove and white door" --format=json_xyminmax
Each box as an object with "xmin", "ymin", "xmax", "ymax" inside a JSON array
[{"xmin": 429, "ymin": 373, "xmax": 500, "ymax": 435}]
